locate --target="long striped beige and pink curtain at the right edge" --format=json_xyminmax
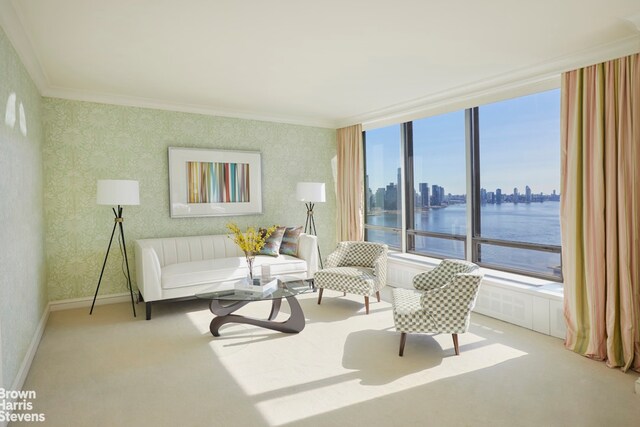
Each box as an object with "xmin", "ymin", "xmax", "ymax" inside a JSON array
[{"xmin": 561, "ymin": 54, "xmax": 640, "ymax": 371}]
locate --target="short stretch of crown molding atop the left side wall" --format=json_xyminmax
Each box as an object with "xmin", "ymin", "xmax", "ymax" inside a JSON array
[{"xmin": 0, "ymin": 0, "xmax": 49, "ymax": 93}]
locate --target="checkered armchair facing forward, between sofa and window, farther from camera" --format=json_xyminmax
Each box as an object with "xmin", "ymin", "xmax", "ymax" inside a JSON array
[{"xmin": 313, "ymin": 242, "xmax": 388, "ymax": 314}]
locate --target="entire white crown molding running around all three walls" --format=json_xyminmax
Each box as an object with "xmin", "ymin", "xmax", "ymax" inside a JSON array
[{"xmin": 0, "ymin": 0, "xmax": 640, "ymax": 129}]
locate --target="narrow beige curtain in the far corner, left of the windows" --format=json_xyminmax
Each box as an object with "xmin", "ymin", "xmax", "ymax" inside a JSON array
[{"xmin": 336, "ymin": 125, "xmax": 364, "ymax": 242}]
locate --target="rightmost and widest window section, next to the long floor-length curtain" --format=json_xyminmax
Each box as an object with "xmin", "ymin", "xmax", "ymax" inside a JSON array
[{"xmin": 474, "ymin": 91, "xmax": 560, "ymax": 275}]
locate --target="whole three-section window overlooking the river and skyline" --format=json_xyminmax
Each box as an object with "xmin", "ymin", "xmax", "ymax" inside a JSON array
[{"xmin": 364, "ymin": 90, "xmax": 562, "ymax": 280}]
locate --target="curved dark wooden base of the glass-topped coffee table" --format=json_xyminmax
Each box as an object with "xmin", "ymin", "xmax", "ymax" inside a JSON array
[{"xmin": 209, "ymin": 296, "xmax": 305, "ymax": 337}]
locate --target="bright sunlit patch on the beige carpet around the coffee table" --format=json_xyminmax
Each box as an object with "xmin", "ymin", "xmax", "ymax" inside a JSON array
[{"xmin": 187, "ymin": 298, "xmax": 527, "ymax": 425}]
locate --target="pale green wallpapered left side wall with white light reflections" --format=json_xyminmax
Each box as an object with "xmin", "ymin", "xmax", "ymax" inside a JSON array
[{"xmin": 0, "ymin": 28, "xmax": 47, "ymax": 389}]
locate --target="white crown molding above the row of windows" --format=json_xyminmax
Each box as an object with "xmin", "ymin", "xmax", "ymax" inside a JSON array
[{"xmin": 338, "ymin": 34, "xmax": 640, "ymax": 130}]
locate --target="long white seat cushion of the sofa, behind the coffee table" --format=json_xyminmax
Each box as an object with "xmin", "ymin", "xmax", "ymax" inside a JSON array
[{"xmin": 161, "ymin": 255, "xmax": 307, "ymax": 289}]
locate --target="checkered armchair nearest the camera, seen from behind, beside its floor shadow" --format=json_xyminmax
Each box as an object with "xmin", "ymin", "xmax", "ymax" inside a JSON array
[{"xmin": 393, "ymin": 259, "xmax": 482, "ymax": 356}]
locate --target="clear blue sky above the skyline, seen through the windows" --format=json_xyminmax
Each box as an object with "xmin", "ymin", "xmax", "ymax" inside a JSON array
[{"xmin": 366, "ymin": 89, "xmax": 560, "ymax": 194}]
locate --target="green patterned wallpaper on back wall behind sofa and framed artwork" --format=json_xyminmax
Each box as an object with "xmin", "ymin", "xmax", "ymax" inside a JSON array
[{"xmin": 43, "ymin": 98, "xmax": 336, "ymax": 301}]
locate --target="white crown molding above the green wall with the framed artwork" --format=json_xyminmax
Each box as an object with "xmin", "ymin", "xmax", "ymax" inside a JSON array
[{"xmin": 42, "ymin": 87, "xmax": 336, "ymax": 129}]
